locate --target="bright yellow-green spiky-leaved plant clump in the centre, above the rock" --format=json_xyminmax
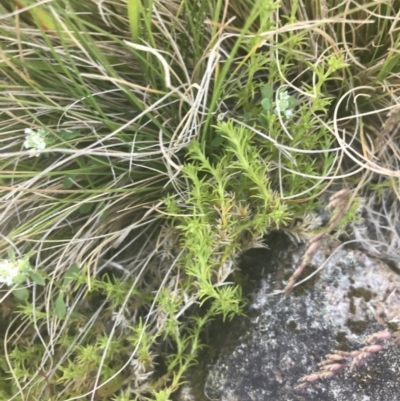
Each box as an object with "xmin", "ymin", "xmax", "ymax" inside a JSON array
[{"xmin": 167, "ymin": 122, "xmax": 290, "ymax": 317}]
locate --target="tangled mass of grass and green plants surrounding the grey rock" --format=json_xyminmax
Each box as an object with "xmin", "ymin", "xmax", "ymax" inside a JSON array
[{"xmin": 0, "ymin": 0, "xmax": 400, "ymax": 401}]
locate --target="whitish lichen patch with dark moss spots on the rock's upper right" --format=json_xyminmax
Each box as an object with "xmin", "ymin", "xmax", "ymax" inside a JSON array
[{"xmin": 319, "ymin": 249, "xmax": 400, "ymax": 334}]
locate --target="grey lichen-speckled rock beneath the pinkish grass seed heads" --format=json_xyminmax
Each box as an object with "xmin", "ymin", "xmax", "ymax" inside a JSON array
[{"xmin": 204, "ymin": 234, "xmax": 400, "ymax": 401}]
